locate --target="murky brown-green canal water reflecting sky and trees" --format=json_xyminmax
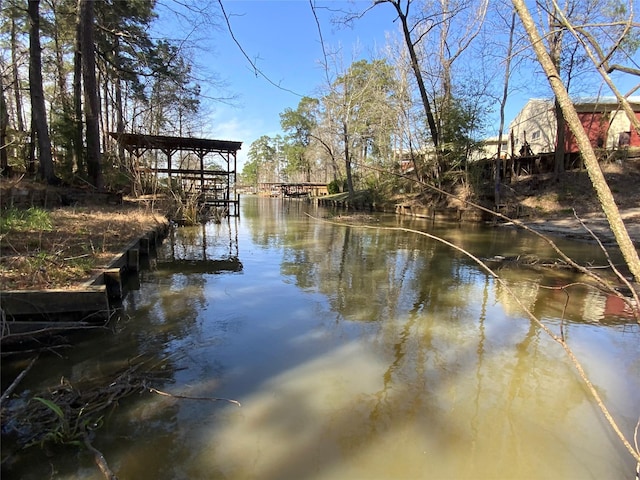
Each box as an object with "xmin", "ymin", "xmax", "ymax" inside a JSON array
[{"xmin": 3, "ymin": 197, "xmax": 640, "ymax": 480}]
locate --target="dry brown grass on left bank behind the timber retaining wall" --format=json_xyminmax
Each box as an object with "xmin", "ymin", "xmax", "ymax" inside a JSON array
[{"xmin": 0, "ymin": 202, "xmax": 166, "ymax": 290}]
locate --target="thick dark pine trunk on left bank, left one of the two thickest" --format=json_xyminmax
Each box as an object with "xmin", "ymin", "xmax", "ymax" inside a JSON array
[{"xmin": 27, "ymin": 0, "xmax": 58, "ymax": 183}]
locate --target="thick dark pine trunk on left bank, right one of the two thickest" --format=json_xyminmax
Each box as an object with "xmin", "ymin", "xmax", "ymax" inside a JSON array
[{"xmin": 80, "ymin": 0, "xmax": 104, "ymax": 189}]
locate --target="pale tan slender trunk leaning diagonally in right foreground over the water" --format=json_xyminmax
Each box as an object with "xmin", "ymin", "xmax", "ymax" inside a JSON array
[{"xmin": 512, "ymin": 0, "xmax": 640, "ymax": 282}]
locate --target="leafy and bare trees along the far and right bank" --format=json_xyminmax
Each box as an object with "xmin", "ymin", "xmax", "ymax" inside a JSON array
[{"xmin": 243, "ymin": 0, "xmax": 640, "ymax": 199}]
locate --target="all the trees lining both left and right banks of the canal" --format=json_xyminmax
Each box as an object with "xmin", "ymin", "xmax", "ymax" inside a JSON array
[{"xmin": 0, "ymin": 0, "xmax": 640, "ymax": 196}]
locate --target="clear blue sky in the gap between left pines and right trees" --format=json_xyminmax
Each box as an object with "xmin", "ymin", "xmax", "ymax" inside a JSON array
[{"xmin": 157, "ymin": 0, "xmax": 636, "ymax": 171}]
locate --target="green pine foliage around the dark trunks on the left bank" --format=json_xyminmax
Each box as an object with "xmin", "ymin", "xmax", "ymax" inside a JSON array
[{"xmin": 0, "ymin": 0, "xmax": 204, "ymax": 188}]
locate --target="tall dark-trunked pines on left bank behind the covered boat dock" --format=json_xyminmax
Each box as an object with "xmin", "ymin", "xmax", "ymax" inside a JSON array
[{"xmin": 0, "ymin": 0, "xmax": 201, "ymax": 189}]
